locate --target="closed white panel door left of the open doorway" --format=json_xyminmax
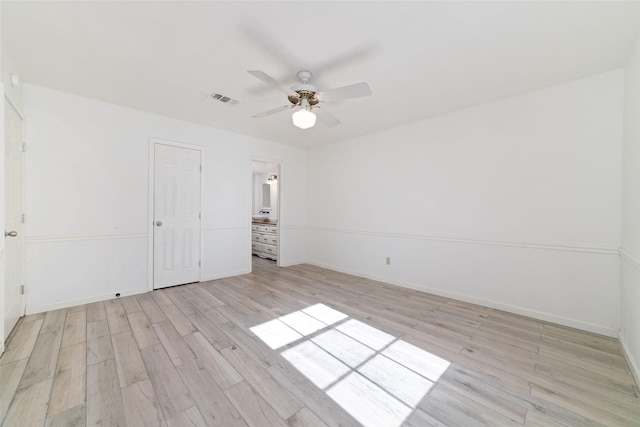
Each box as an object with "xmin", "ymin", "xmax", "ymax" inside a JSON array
[{"xmin": 153, "ymin": 144, "xmax": 201, "ymax": 289}]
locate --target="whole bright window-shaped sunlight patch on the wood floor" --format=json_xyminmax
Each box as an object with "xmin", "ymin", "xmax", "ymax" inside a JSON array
[{"xmin": 251, "ymin": 304, "xmax": 451, "ymax": 427}]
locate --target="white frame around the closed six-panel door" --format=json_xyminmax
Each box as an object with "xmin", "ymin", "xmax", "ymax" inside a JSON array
[{"xmin": 147, "ymin": 138, "xmax": 204, "ymax": 292}]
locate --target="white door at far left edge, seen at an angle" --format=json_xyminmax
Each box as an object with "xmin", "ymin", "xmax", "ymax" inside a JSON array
[{"xmin": 3, "ymin": 100, "xmax": 24, "ymax": 340}]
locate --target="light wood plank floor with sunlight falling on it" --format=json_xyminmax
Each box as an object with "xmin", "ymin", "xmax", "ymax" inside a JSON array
[{"xmin": 0, "ymin": 257, "xmax": 640, "ymax": 427}]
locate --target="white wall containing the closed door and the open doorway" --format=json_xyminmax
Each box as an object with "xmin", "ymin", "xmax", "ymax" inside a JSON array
[{"xmin": 24, "ymin": 85, "xmax": 306, "ymax": 312}]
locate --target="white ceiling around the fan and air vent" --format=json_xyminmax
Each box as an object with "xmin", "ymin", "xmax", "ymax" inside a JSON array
[{"xmin": 1, "ymin": 1, "xmax": 640, "ymax": 148}]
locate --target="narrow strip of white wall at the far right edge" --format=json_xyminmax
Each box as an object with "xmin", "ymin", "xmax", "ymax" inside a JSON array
[{"xmin": 620, "ymin": 30, "xmax": 640, "ymax": 381}]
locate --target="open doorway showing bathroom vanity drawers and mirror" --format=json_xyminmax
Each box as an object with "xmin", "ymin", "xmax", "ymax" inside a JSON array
[{"xmin": 251, "ymin": 160, "xmax": 281, "ymax": 266}]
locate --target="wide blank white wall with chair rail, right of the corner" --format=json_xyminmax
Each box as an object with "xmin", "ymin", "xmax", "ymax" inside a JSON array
[{"xmin": 307, "ymin": 70, "xmax": 624, "ymax": 335}]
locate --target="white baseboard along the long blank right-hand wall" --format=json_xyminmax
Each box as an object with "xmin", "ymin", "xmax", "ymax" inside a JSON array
[{"xmin": 307, "ymin": 261, "xmax": 618, "ymax": 338}]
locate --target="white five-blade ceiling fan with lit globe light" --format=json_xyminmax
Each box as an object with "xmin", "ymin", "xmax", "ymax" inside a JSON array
[{"xmin": 248, "ymin": 70, "xmax": 371, "ymax": 129}]
